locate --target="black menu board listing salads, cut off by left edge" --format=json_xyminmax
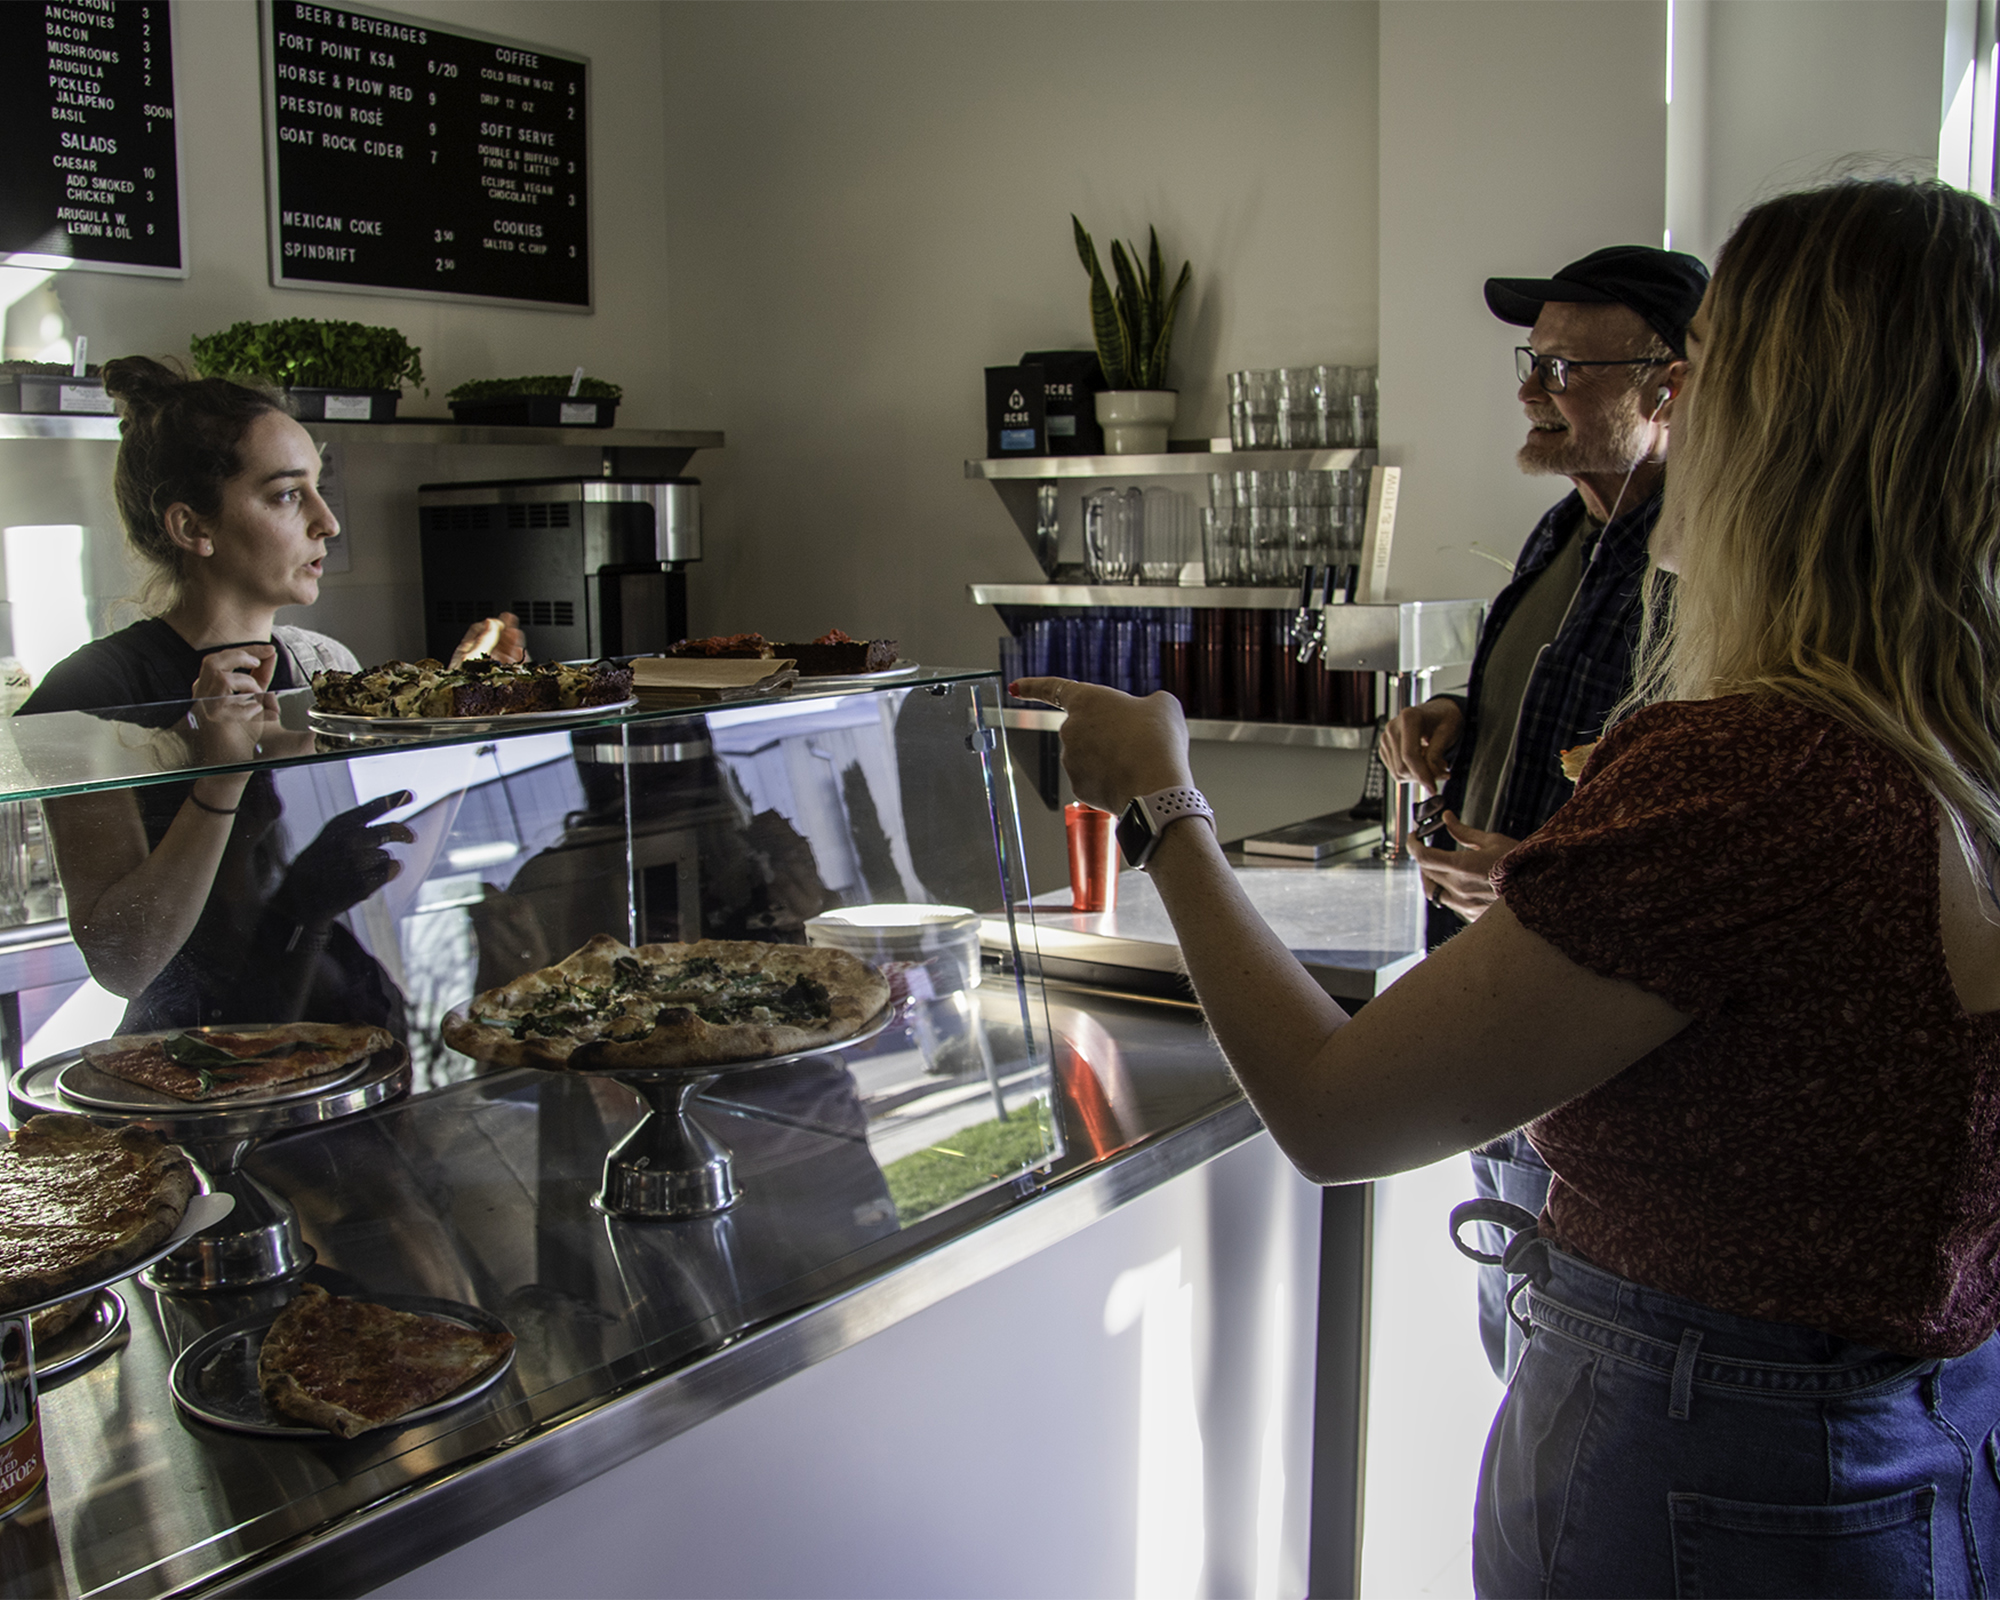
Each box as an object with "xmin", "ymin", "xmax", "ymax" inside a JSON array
[{"xmin": 0, "ymin": 0, "xmax": 188, "ymax": 278}]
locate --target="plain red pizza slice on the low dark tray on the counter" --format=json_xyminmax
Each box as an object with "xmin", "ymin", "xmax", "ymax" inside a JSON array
[{"xmin": 256, "ymin": 1284, "xmax": 514, "ymax": 1438}]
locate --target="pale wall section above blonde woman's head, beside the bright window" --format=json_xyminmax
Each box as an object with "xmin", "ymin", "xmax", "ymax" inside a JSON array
[{"xmin": 1668, "ymin": 0, "xmax": 1946, "ymax": 260}]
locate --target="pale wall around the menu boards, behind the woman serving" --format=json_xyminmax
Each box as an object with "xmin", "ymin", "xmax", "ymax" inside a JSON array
[{"xmin": 0, "ymin": 0, "xmax": 680, "ymax": 660}]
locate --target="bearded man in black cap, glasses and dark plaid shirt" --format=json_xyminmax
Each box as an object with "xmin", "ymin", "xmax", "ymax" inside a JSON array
[{"xmin": 1380, "ymin": 244, "xmax": 1708, "ymax": 1378}]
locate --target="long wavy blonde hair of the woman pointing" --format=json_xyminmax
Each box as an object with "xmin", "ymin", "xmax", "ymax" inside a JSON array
[{"xmin": 1620, "ymin": 178, "xmax": 2000, "ymax": 876}]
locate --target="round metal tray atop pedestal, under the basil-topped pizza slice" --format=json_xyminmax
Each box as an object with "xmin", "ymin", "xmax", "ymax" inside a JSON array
[{"xmin": 8, "ymin": 1024, "xmax": 410, "ymax": 1140}]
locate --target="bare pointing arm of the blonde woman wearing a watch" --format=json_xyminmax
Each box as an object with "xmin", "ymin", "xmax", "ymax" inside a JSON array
[{"xmin": 1016, "ymin": 678, "xmax": 1690, "ymax": 1184}]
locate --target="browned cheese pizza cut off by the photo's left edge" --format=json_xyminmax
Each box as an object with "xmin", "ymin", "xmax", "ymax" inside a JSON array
[{"xmin": 0, "ymin": 1114, "xmax": 194, "ymax": 1312}]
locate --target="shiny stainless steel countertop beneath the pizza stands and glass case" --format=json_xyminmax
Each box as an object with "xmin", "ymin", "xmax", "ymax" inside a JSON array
[{"xmin": 0, "ymin": 986, "xmax": 1258, "ymax": 1596}]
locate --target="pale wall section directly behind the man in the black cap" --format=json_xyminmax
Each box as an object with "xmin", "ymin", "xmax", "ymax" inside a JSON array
[{"xmin": 1380, "ymin": 0, "xmax": 1666, "ymax": 616}]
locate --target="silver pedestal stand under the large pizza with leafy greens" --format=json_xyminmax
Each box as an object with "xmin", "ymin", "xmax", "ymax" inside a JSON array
[{"xmin": 452, "ymin": 1002, "xmax": 896, "ymax": 1222}]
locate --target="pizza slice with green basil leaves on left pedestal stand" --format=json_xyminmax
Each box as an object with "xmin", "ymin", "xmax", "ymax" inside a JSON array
[{"xmin": 84, "ymin": 1022, "xmax": 396, "ymax": 1102}]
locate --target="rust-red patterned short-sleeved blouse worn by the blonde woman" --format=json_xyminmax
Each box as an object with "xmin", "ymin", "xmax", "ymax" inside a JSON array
[{"xmin": 1494, "ymin": 696, "xmax": 2000, "ymax": 1356}]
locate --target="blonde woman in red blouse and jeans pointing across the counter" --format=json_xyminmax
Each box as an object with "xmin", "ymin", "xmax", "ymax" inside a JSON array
[{"xmin": 1018, "ymin": 182, "xmax": 2000, "ymax": 1596}]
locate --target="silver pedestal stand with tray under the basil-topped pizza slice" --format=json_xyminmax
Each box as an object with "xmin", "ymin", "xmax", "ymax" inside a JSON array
[{"xmin": 8, "ymin": 1028, "xmax": 410, "ymax": 1294}]
